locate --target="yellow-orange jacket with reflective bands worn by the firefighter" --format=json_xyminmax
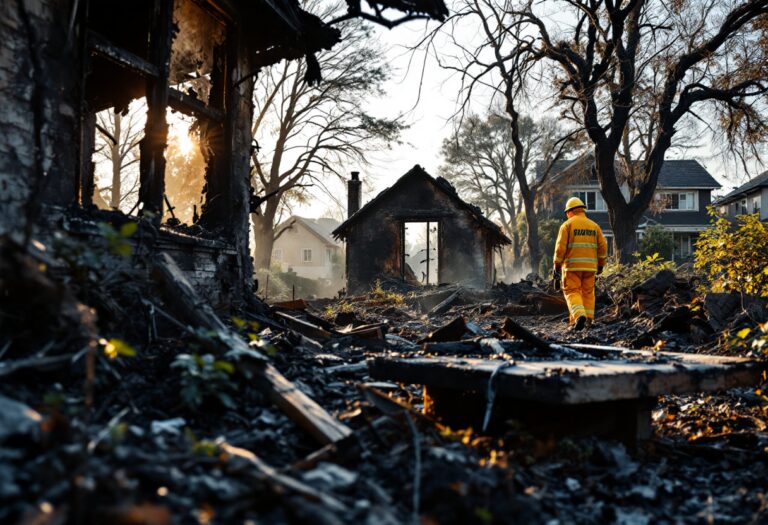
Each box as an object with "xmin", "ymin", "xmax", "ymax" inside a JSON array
[{"xmin": 555, "ymin": 210, "xmax": 608, "ymax": 272}]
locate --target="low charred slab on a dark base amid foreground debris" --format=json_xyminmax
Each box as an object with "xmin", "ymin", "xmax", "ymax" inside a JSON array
[{"xmin": 368, "ymin": 353, "xmax": 764, "ymax": 445}]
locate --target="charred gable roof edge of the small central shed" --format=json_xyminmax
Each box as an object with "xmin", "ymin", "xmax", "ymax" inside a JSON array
[{"xmin": 333, "ymin": 164, "xmax": 512, "ymax": 245}]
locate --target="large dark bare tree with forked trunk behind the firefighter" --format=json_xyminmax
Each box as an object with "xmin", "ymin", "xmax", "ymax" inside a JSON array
[{"xmin": 504, "ymin": 0, "xmax": 768, "ymax": 261}]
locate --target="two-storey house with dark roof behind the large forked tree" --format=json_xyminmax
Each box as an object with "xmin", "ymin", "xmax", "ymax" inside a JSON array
[{"xmin": 537, "ymin": 155, "xmax": 721, "ymax": 261}]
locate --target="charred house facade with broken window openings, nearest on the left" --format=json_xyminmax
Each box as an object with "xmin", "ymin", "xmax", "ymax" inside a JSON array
[{"xmin": 0, "ymin": 0, "xmax": 445, "ymax": 302}]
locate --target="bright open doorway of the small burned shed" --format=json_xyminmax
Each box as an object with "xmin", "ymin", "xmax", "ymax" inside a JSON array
[{"xmin": 400, "ymin": 221, "xmax": 440, "ymax": 285}]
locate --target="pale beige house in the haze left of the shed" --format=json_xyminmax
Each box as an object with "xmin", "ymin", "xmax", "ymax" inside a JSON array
[{"xmin": 272, "ymin": 215, "xmax": 344, "ymax": 281}]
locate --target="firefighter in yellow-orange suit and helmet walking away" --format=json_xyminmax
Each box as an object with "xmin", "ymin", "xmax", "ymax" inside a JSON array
[{"xmin": 553, "ymin": 197, "xmax": 608, "ymax": 330}]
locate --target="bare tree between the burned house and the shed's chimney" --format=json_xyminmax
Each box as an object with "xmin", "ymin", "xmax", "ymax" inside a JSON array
[{"xmin": 252, "ymin": 1, "xmax": 403, "ymax": 268}]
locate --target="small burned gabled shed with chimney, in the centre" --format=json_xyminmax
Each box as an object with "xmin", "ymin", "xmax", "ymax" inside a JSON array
[{"xmin": 333, "ymin": 165, "xmax": 510, "ymax": 293}]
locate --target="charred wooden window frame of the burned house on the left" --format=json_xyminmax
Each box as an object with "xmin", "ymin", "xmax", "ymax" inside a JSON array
[{"xmin": 78, "ymin": 0, "xmax": 231, "ymax": 226}]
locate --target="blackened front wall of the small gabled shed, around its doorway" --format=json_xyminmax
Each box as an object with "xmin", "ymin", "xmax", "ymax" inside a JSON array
[{"xmin": 346, "ymin": 175, "xmax": 493, "ymax": 294}]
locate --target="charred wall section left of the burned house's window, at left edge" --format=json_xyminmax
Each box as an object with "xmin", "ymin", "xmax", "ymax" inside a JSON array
[{"xmin": 0, "ymin": 0, "xmax": 80, "ymax": 234}]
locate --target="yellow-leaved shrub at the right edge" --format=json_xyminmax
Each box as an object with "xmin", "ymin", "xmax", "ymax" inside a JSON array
[{"xmin": 694, "ymin": 210, "xmax": 768, "ymax": 297}]
